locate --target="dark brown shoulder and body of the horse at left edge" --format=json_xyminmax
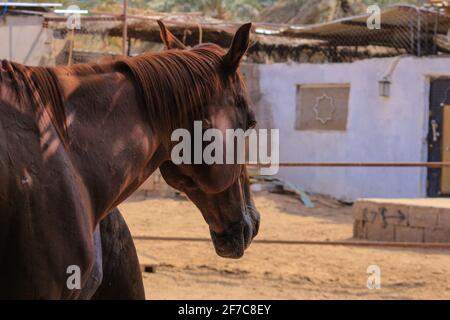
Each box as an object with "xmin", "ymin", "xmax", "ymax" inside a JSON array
[{"xmin": 0, "ymin": 61, "xmax": 94, "ymax": 299}]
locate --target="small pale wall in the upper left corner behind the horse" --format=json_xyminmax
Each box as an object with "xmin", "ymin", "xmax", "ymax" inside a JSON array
[{"xmin": 0, "ymin": 15, "xmax": 52, "ymax": 65}]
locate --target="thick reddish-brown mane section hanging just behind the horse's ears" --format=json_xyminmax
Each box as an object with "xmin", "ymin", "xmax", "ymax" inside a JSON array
[{"xmin": 115, "ymin": 44, "xmax": 232, "ymax": 141}]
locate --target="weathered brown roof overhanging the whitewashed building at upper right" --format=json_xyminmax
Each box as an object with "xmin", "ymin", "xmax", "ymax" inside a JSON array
[{"xmin": 255, "ymin": 5, "xmax": 450, "ymax": 55}]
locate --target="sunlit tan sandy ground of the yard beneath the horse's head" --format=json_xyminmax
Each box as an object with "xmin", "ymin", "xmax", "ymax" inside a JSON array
[{"xmin": 120, "ymin": 192, "xmax": 450, "ymax": 299}]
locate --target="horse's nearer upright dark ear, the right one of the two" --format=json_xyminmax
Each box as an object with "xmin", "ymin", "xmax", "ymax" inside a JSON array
[{"xmin": 224, "ymin": 23, "xmax": 252, "ymax": 73}]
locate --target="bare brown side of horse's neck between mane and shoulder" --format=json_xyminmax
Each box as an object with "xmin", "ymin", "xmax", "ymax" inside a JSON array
[{"xmin": 57, "ymin": 65, "xmax": 165, "ymax": 222}]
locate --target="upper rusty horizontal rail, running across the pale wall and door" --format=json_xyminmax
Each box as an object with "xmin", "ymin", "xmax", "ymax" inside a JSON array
[{"xmin": 247, "ymin": 162, "xmax": 450, "ymax": 168}]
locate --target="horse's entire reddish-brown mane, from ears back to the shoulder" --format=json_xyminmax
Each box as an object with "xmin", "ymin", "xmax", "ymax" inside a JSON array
[{"xmin": 3, "ymin": 44, "xmax": 245, "ymax": 146}]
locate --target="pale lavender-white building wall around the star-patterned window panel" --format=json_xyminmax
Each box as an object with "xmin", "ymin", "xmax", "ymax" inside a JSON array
[{"xmin": 260, "ymin": 57, "xmax": 450, "ymax": 201}]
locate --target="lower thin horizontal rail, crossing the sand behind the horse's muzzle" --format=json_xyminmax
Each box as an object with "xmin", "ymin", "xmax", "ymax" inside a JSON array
[{"xmin": 133, "ymin": 236, "xmax": 450, "ymax": 249}]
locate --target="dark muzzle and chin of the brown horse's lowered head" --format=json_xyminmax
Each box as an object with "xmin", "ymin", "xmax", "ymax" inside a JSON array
[{"xmin": 210, "ymin": 207, "xmax": 259, "ymax": 259}]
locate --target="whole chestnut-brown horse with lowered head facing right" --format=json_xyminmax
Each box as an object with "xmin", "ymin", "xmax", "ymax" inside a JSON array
[{"xmin": 0, "ymin": 24, "xmax": 259, "ymax": 299}]
